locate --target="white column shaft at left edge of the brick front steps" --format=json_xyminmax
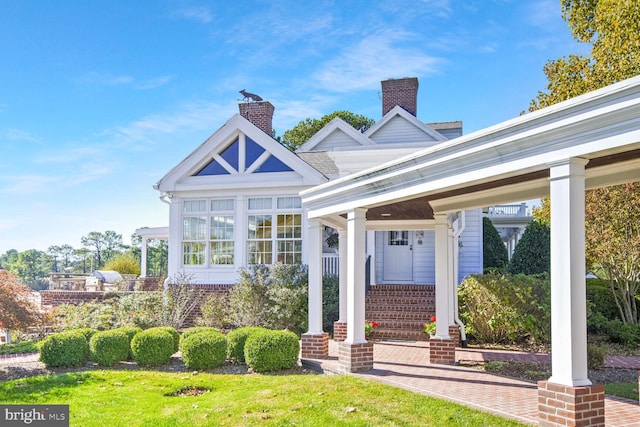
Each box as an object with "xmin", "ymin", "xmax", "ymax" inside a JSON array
[{"xmin": 345, "ymin": 208, "xmax": 367, "ymax": 344}]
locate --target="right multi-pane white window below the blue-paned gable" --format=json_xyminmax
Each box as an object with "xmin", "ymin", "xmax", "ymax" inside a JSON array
[{"xmin": 247, "ymin": 196, "xmax": 302, "ymax": 264}]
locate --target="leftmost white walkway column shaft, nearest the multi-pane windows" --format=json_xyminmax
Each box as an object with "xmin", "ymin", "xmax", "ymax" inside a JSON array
[{"xmin": 306, "ymin": 219, "xmax": 322, "ymax": 334}]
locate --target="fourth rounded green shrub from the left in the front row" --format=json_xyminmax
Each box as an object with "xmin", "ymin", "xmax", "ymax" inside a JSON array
[{"xmin": 182, "ymin": 330, "xmax": 227, "ymax": 370}]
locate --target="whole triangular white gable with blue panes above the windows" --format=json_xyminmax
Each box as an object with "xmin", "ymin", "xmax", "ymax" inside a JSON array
[{"xmin": 155, "ymin": 114, "xmax": 327, "ymax": 192}]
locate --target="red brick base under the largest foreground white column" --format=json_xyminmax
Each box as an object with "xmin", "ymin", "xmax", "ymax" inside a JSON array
[{"xmin": 538, "ymin": 381, "xmax": 605, "ymax": 427}]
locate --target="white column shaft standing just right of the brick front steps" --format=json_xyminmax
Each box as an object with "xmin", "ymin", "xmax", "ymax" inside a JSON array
[{"xmin": 434, "ymin": 214, "xmax": 451, "ymax": 339}]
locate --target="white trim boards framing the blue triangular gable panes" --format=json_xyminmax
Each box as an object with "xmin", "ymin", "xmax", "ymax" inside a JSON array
[{"xmin": 154, "ymin": 114, "xmax": 327, "ymax": 192}]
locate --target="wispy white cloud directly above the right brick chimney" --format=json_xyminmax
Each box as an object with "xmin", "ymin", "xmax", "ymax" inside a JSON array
[{"xmin": 314, "ymin": 30, "xmax": 441, "ymax": 92}]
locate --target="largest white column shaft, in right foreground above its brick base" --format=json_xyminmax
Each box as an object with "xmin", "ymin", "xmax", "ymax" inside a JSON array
[{"xmin": 549, "ymin": 158, "xmax": 591, "ymax": 387}]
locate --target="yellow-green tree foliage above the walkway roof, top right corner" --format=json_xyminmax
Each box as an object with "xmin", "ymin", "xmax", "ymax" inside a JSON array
[{"xmin": 529, "ymin": 0, "xmax": 640, "ymax": 111}]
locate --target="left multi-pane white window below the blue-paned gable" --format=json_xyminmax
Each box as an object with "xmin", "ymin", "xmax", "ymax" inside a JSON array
[{"xmin": 182, "ymin": 199, "xmax": 234, "ymax": 265}]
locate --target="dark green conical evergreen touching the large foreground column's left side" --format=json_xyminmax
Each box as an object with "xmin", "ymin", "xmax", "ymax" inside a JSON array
[{"xmin": 507, "ymin": 220, "xmax": 551, "ymax": 274}]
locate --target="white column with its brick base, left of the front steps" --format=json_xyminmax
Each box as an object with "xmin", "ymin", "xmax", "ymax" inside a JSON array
[{"xmin": 338, "ymin": 208, "xmax": 373, "ymax": 372}]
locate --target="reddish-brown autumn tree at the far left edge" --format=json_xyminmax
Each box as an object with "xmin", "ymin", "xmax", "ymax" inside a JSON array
[{"xmin": 0, "ymin": 270, "xmax": 38, "ymax": 330}]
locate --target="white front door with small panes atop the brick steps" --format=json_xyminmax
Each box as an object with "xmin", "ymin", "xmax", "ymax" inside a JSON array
[{"xmin": 382, "ymin": 230, "xmax": 413, "ymax": 281}]
